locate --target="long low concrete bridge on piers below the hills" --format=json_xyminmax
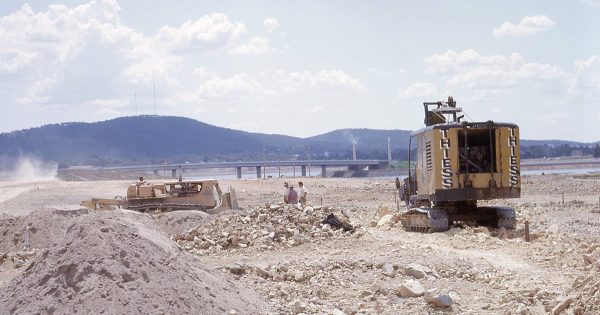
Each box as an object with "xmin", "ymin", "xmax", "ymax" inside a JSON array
[{"xmin": 99, "ymin": 160, "xmax": 388, "ymax": 178}]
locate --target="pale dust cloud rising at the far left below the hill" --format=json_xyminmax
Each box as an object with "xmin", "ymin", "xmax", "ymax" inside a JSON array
[{"xmin": 0, "ymin": 157, "xmax": 58, "ymax": 182}]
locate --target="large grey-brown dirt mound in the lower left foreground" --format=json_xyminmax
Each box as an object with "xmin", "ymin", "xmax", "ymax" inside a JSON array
[{"xmin": 0, "ymin": 212, "xmax": 264, "ymax": 314}]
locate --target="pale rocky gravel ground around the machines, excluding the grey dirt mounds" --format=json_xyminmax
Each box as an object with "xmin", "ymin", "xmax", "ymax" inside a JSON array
[{"xmin": 0, "ymin": 175, "xmax": 600, "ymax": 314}]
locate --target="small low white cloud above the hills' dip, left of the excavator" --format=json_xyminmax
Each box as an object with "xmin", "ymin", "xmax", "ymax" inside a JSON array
[{"xmin": 286, "ymin": 70, "xmax": 365, "ymax": 91}]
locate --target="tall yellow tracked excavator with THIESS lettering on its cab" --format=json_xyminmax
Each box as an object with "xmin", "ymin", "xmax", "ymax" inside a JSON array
[{"xmin": 396, "ymin": 97, "xmax": 521, "ymax": 232}]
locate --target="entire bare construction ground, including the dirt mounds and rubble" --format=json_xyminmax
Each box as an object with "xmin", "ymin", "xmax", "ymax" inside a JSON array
[{"xmin": 0, "ymin": 175, "xmax": 600, "ymax": 314}]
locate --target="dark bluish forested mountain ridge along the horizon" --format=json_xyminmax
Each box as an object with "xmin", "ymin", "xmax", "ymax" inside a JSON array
[{"xmin": 0, "ymin": 116, "xmax": 589, "ymax": 165}]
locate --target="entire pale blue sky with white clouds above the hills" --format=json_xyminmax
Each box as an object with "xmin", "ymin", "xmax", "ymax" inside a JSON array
[{"xmin": 0, "ymin": 0, "xmax": 600, "ymax": 142}]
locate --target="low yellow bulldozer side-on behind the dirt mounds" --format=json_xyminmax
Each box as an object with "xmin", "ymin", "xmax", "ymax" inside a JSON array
[{"xmin": 81, "ymin": 177, "xmax": 238, "ymax": 212}]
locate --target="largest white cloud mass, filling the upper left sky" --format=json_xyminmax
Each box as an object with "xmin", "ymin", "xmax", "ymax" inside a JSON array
[{"xmin": 0, "ymin": 0, "xmax": 264, "ymax": 107}]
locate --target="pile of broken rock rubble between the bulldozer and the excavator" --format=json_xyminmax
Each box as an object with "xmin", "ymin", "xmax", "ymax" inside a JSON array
[{"xmin": 171, "ymin": 204, "xmax": 364, "ymax": 255}]
